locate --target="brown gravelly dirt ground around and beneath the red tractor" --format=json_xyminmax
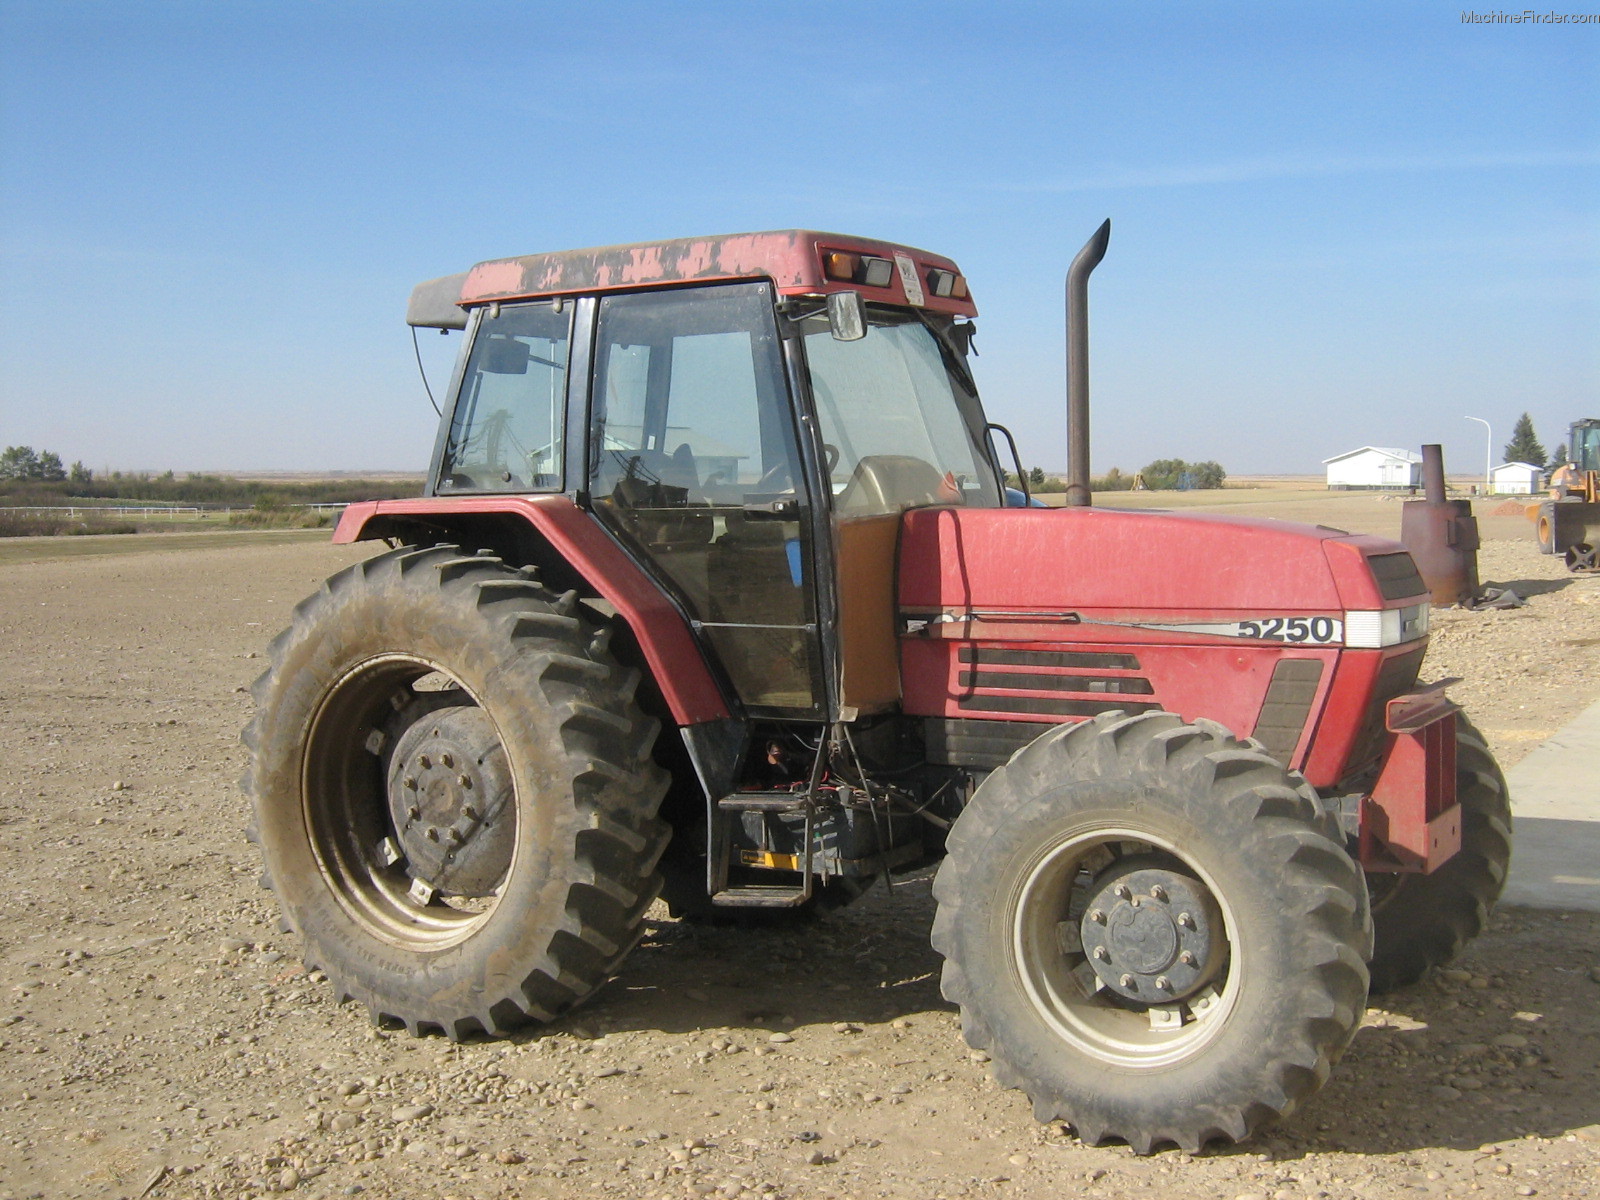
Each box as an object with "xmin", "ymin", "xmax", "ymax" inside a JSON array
[{"xmin": 0, "ymin": 491, "xmax": 1600, "ymax": 1200}]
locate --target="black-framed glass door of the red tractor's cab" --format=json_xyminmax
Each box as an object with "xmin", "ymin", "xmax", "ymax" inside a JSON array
[{"xmin": 587, "ymin": 283, "xmax": 824, "ymax": 718}]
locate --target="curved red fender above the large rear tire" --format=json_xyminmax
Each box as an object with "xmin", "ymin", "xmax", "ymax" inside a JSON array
[{"xmin": 342, "ymin": 496, "xmax": 733, "ymax": 726}]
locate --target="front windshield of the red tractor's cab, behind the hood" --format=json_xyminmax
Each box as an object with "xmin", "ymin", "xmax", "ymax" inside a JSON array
[{"xmin": 803, "ymin": 306, "xmax": 1000, "ymax": 517}]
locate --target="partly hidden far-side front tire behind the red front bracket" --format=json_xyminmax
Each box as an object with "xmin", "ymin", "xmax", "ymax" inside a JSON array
[{"xmin": 1366, "ymin": 714, "xmax": 1512, "ymax": 992}]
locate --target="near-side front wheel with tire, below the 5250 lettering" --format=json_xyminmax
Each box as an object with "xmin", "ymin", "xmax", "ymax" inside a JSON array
[{"xmin": 933, "ymin": 714, "xmax": 1371, "ymax": 1154}]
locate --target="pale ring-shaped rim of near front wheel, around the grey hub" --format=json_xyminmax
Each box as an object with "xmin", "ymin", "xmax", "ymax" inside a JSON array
[{"xmin": 1006, "ymin": 827, "xmax": 1248, "ymax": 1070}]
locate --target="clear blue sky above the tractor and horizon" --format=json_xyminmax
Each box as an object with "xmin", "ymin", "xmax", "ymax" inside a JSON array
[{"xmin": 0, "ymin": 0, "xmax": 1600, "ymax": 474}]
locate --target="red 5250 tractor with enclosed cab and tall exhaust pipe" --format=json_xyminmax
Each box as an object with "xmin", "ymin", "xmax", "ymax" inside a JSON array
[{"xmin": 245, "ymin": 227, "xmax": 1510, "ymax": 1152}]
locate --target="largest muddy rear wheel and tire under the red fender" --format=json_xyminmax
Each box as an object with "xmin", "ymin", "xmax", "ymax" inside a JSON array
[{"xmin": 245, "ymin": 546, "xmax": 667, "ymax": 1038}]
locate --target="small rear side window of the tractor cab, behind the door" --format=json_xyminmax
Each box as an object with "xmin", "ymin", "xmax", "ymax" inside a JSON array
[{"xmin": 438, "ymin": 301, "xmax": 571, "ymax": 491}]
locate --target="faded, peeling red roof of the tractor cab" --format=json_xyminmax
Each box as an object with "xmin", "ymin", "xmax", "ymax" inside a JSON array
[{"xmin": 406, "ymin": 229, "xmax": 978, "ymax": 330}]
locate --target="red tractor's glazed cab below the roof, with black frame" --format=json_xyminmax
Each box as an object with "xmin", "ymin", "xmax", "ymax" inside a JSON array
[{"xmin": 430, "ymin": 235, "xmax": 1003, "ymax": 722}]
